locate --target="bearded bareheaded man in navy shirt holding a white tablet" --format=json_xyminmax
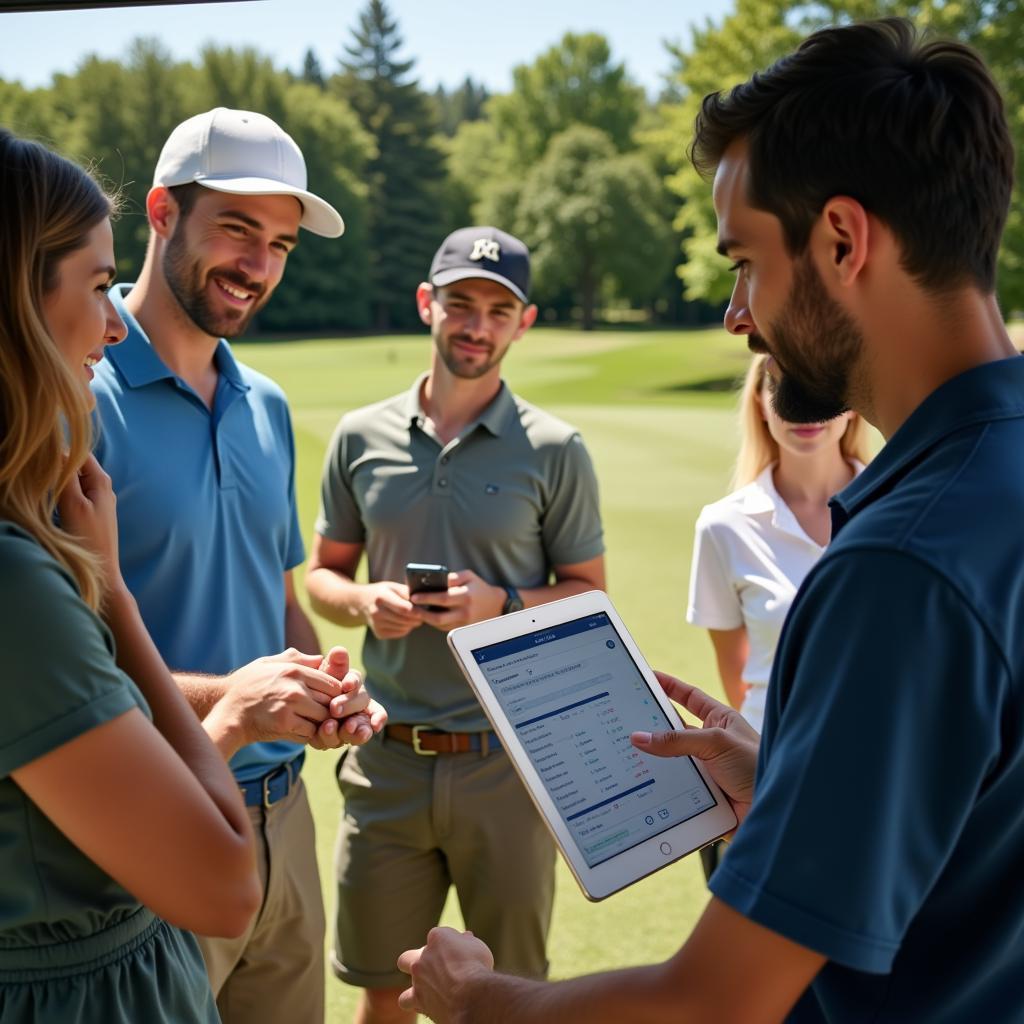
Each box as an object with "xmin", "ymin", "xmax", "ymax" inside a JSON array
[{"xmin": 400, "ymin": 19, "xmax": 1024, "ymax": 1024}]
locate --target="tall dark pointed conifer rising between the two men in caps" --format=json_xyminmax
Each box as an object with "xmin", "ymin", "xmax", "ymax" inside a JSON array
[{"xmin": 333, "ymin": 0, "xmax": 444, "ymax": 331}]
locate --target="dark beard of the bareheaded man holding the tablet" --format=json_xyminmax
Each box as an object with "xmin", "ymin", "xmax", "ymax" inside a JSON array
[{"xmin": 749, "ymin": 254, "xmax": 863, "ymax": 423}]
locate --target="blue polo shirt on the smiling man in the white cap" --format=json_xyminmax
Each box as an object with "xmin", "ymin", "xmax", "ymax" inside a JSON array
[{"xmin": 92, "ymin": 285, "xmax": 305, "ymax": 781}]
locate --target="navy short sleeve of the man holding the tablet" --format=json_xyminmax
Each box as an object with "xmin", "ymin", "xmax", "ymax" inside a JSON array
[{"xmin": 711, "ymin": 549, "xmax": 1011, "ymax": 973}]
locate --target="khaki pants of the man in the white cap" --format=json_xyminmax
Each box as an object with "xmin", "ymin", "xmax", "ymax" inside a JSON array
[{"xmin": 199, "ymin": 779, "xmax": 325, "ymax": 1024}]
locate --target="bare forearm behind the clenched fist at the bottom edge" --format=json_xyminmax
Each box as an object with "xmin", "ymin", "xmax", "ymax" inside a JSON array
[{"xmin": 452, "ymin": 964, "xmax": 684, "ymax": 1024}]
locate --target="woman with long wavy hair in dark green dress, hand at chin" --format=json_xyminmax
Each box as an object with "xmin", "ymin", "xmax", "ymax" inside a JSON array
[{"xmin": 0, "ymin": 130, "xmax": 259, "ymax": 1024}]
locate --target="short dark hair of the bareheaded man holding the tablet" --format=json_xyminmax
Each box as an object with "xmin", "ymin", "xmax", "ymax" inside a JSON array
[{"xmin": 690, "ymin": 17, "xmax": 1014, "ymax": 292}]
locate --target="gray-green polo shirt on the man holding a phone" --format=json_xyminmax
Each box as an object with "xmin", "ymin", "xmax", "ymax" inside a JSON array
[{"xmin": 316, "ymin": 375, "xmax": 604, "ymax": 731}]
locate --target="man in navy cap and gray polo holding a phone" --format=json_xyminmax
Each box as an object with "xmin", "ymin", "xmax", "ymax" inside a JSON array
[{"xmin": 306, "ymin": 227, "xmax": 604, "ymax": 1024}]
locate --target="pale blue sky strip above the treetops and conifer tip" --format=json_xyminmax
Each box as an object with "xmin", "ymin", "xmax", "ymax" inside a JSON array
[{"xmin": 0, "ymin": 0, "xmax": 732, "ymax": 92}]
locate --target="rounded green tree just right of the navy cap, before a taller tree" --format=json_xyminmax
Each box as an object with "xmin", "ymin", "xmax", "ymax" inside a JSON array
[{"xmin": 516, "ymin": 125, "xmax": 673, "ymax": 331}]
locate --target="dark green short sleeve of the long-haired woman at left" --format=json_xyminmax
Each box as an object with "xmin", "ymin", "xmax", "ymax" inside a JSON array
[{"xmin": 0, "ymin": 535, "xmax": 139, "ymax": 777}]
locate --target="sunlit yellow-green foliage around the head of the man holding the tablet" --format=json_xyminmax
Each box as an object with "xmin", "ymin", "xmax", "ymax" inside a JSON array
[{"xmin": 653, "ymin": 0, "xmax": 1024, "ymax": 309}]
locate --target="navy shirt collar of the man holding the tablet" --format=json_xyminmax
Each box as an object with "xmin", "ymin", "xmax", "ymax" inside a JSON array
[{"xmin": 829, "ymin": 356, "xmax": 1024, "ymax": 537}]
